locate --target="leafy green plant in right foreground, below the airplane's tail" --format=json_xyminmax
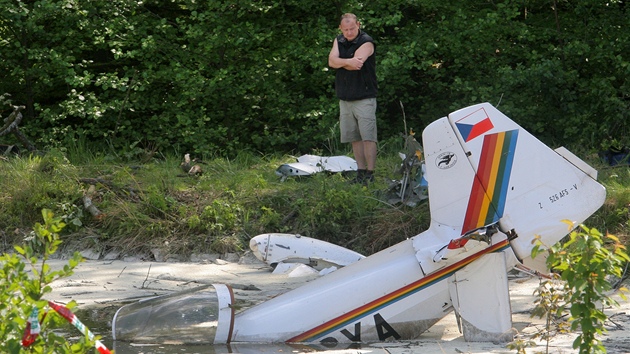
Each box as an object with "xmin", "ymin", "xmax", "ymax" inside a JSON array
[{"xmin": 532, "ymin": 221, "xmax": 630, "ymax": 354}]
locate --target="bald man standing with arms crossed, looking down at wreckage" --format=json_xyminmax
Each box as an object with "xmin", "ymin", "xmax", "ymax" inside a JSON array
[{"xmin": 328, "ymin": 13, "xmax": 378, "ymax": 184}]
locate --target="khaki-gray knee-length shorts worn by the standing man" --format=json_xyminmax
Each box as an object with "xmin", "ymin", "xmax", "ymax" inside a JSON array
[{"xmin": 339, "ymin": 98, "xmax": 377, "ymax": 143}]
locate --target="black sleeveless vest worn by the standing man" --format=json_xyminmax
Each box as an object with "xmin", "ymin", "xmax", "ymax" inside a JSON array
[{"xmin": 335, "ymin": 31, "xmax": 378, "ymax": 101}]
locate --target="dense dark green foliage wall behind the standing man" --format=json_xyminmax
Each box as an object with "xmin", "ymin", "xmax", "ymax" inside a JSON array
[{"xmin": 0, "ymin": 0, "xmax": 630, "ymax": 156}]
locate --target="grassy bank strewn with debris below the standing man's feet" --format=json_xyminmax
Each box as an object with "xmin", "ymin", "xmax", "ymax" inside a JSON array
[{"xmin": 0, "ymin": 145, "xmax": 630, "ymax": 258}]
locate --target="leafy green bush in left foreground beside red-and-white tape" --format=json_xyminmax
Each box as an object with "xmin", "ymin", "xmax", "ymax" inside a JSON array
[{"xmin": 0, "ymin": 209, "xmax": 94, "ymax": 353}]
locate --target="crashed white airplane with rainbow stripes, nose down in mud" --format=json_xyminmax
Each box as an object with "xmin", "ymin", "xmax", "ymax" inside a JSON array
[{"xmin": 113, "ymin": 103, "xmax": 606, "ymax": 344}]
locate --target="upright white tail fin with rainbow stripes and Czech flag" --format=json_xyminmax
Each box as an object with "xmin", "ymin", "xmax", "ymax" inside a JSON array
[{"xmin": 423, "ymin": 103, "xmax": 606, "ymax": 271}]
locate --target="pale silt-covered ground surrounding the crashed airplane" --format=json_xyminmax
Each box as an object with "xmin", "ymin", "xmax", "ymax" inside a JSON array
[{"xmin": 50, "ymin": 255, "xmax": 630, "ymax": 354}]
